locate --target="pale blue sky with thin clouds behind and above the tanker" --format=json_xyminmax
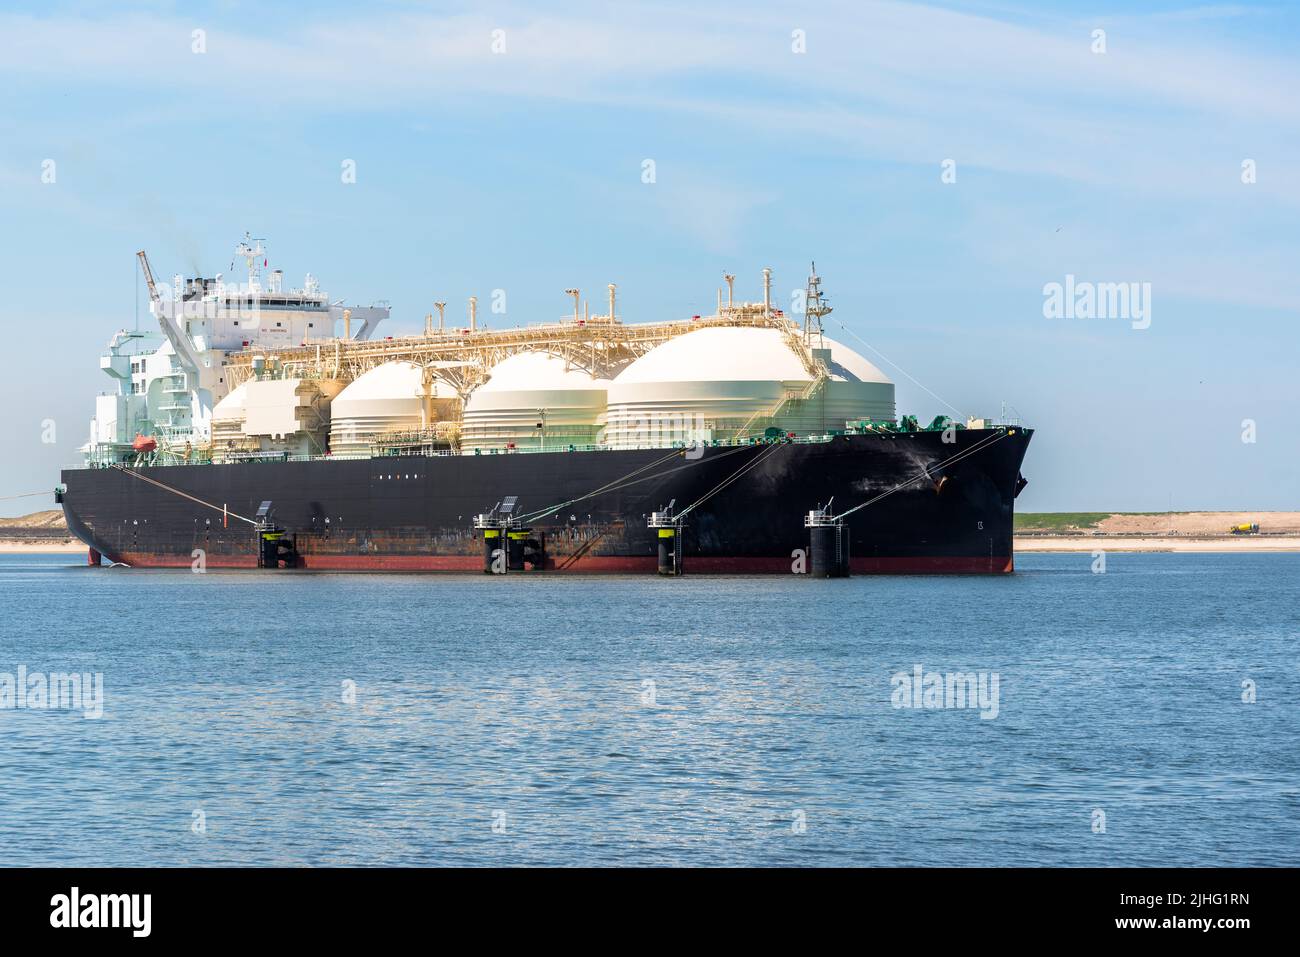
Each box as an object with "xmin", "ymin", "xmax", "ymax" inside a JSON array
[{"xmin": 0, "ymin": 3, "xmax": 1300, "ymax": 514}]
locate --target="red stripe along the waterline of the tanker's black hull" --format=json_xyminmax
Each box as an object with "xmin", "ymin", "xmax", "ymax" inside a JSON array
[{"xmin": 117, "ymin": 553, "xmax": 1015, "ymax": 575}]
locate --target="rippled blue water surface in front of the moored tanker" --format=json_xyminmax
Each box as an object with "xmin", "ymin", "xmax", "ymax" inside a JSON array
[{"xmin": 0, "ymin": 554, "xmax": 1300, "ymax": 865}]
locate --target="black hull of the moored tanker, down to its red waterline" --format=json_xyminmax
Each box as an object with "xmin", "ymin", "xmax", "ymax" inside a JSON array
[{"xmin": 62, "ymin": 428, "xmax": 1032, "ymax": 573}]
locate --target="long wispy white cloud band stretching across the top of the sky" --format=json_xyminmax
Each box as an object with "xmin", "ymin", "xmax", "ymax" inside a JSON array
[{"xmin": 0, "ymin": 3, "xmax": 1300, "ymax": 204}]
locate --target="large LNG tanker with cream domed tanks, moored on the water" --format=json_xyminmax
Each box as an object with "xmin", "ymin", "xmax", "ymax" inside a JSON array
[{"xmin": 56, "ymin": 237, "xmax": 1032, "ymax": 573}]
